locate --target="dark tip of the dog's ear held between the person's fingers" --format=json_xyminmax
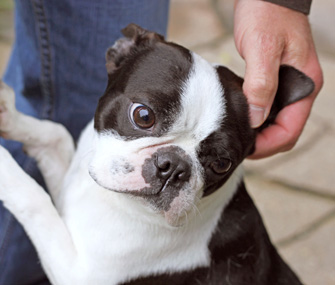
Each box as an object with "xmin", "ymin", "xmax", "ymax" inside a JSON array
[{"xmin": 257, "ymin": 65, "xmax": 315, "ymax": 131}]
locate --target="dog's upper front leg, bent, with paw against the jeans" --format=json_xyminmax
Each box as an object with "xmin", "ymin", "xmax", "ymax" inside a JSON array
[{"xmin": 0, "ymin": 80, "xmax": 74, "ymax": 201}]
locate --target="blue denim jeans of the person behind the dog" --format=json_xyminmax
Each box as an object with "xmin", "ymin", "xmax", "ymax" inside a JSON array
[{"xmin": 0, "ymin": 0, "xmax": 169, "ymax": 285}]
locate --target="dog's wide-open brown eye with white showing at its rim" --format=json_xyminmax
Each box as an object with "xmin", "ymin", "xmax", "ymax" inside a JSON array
[{"xmin": 130, "ymin": 103, "xmax": 155, "ymax": 129}]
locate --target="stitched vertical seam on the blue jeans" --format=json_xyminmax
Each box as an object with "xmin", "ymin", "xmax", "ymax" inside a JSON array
[{"xmin": 32, "ymin": 0, "xmax": 54, "ymax": 120}]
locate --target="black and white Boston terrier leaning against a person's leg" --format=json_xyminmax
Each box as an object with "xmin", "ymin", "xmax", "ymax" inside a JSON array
[{"xmin": 0, "ymin": 24, "xmax": 314, "ymax": 285}]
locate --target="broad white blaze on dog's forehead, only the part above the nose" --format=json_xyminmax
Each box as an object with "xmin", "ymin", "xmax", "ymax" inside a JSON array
[{"xmin": 171, "ymin": 53, "xmax": 226, "ymax": 144}]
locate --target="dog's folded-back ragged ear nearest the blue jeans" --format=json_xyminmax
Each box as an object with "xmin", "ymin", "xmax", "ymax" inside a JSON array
[{"xmin": 106, "ymin": 24, "xmax": 164, "ymax": 74}]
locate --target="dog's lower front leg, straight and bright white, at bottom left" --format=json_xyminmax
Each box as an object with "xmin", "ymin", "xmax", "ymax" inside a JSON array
[{"xmin": 0, "ymin": 146, "xmax": 77, "ymax": 284}]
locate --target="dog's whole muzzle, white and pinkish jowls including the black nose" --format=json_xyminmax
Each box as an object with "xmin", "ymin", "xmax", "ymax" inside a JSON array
[{"xmin": 89, "ymin": 145, "xmax": 203, "ymax": 226}]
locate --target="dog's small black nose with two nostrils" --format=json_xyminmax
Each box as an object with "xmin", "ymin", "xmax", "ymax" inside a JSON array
[{"xmin": 155, "ymin": 152, "xmax": 191, "ymax": 183}]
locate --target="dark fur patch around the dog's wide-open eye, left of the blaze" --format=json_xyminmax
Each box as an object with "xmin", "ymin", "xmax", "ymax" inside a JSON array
[{"xmin": 94, "ymin": 25, "xmax": 192, "ymax": 139}]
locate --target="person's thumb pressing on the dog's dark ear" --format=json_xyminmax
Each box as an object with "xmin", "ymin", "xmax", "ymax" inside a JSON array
[{"xmin": 243, "ymin": 37, "xmax": 280, "ymax": 128}]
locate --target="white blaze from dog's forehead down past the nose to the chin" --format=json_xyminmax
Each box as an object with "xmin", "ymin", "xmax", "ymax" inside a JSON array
[{"xmin": 161, "ymin": 53, "xmax": 226, "ymax": 226}]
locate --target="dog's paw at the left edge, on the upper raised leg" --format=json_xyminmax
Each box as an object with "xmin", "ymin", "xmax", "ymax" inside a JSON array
[{"xmin": 0, "ymin": 80, "xmax": 16, "ymax": 138}]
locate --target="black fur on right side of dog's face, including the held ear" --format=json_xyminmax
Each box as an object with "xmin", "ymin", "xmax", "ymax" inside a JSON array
[{"xmin": 199, "ymin": 65, "xmax": 314, "ymax": 196}]
